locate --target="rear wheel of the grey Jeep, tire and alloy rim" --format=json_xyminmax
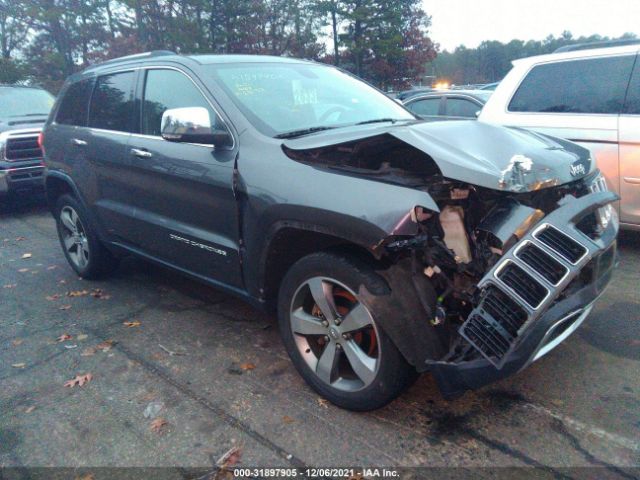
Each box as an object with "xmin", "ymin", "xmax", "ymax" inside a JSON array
[{"xmin": 56, "ymin": 195, "xmax": 116, "ymax": 279}]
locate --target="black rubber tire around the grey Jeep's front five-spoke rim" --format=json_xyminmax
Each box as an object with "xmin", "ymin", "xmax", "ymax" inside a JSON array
[{"xmin": 278, "ymin": 252, "xmax": 418, "ymax": 411}]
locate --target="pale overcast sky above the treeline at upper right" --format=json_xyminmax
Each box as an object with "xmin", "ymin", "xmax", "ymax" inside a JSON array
[{"xmin": 422, "ymin": 0, "xmax": 640, "ymax": 51}]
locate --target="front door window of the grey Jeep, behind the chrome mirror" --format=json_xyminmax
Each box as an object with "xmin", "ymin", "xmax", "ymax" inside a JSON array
[{"xmin": 142, "ymin": 69, "xmax": 225, "ymax": 136}]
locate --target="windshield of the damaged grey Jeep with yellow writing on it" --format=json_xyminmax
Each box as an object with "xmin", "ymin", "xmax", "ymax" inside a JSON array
[{"xmin": 205, "ymin": 63, "xmax": 415, "ymax": 137}]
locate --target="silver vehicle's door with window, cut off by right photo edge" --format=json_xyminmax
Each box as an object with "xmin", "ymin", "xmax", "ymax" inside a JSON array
[{"xmin": 620, "ymin": 54, "xmax": 640, "ymax": 225}]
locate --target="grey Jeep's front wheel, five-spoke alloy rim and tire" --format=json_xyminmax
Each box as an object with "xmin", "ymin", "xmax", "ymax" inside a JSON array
[{"xmin": 278, "ymin": 249, "xmax": 416, "ymax": 411}]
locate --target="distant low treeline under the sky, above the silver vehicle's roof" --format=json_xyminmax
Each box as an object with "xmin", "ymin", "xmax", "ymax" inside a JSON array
[{"xmin": 430, "ymin": 31, "xmax": 635, "ymax": 85}]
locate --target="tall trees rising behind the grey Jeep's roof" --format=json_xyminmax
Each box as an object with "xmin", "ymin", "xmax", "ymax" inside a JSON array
[{"xmin": 0, "ymin": 0, "xmax": 436, "ymax": 91}]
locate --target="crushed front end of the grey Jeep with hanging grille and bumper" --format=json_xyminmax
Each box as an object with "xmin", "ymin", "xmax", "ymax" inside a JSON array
[{"xmin": 387, "ymin": 171, "xmax": 618, "ymax": 397}]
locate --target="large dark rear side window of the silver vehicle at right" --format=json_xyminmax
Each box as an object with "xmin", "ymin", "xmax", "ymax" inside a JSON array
[{"xmin": 509, "ymin": 55, "xmax": 634, "ymax": 113}]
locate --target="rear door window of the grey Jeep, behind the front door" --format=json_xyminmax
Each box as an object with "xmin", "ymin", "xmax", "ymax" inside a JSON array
[{"xmin": 89, "ymin": 72, "xmax": 135, "ymax": 132}]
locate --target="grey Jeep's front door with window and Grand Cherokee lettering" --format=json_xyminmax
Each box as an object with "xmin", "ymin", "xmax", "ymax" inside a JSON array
[{"xmin": 127, "ymin": 68, "xmax": 241, "ymax": 287}]
